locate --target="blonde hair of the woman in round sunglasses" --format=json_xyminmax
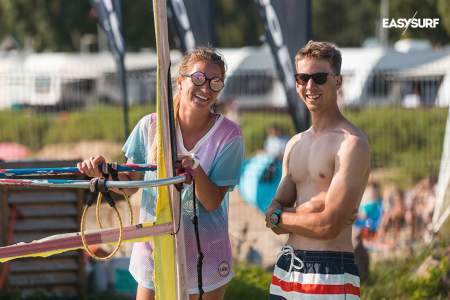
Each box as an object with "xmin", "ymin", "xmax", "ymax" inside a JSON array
[{"xmin": 150, "ymin": 47, "xmax": 226, "ymax": 163}]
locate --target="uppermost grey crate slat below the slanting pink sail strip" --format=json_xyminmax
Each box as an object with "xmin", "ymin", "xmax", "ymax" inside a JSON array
[{"xmin": 9, "ymin": 257, "xmax": 79, "ymax": 273}]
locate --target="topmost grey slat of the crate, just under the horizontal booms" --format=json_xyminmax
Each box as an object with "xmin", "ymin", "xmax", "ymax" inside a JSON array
[{"xmin": 8, "ymin": 189, "xmax": 78, "ymax": 204}]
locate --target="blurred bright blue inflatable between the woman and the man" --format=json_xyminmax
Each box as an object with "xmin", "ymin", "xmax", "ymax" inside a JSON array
[{"xmin": 239, "ymin": 154, "xmax": 281, "ymax": 213}]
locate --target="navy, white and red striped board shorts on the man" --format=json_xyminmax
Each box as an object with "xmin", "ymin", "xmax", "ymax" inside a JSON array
[{"xmin": 269, "ymin": 246, "xmax": 360, "ymax": 300}]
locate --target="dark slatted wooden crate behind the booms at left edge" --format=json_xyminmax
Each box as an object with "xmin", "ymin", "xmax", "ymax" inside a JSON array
[{"xmin": 0, "ymin": 161, "xmax": 87, "ymax": 295}]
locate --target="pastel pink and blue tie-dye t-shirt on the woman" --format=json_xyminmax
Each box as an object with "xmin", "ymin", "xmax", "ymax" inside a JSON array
[{"xmin": 123, "ymin": 114, "xmax": 243, "ymax": 294}]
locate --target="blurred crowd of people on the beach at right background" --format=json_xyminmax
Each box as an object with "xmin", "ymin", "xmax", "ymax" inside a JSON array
[{"xmin": 354, "ymin": 177, "xmax": 436, "ymax": 248}]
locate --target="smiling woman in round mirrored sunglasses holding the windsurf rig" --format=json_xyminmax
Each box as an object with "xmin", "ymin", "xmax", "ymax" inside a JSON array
[{"xmin": 78, "ymin": 48, "xmax": 243, "ymax": 300}]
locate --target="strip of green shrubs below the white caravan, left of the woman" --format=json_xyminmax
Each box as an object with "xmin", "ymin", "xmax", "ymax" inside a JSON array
[{"xmin": 0, "ymin": 106, "xmax": 155, "ymax": 150}]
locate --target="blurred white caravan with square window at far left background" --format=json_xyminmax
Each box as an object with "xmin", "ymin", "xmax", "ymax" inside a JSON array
[{"xmin": 0, "ymin": 51, "xmax": 160, "ymax": 108}]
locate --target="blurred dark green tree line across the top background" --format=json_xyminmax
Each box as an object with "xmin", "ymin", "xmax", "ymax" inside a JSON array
[{"xmin": 0, "ymin": 0, "xmax": 450, "ymax": 52}]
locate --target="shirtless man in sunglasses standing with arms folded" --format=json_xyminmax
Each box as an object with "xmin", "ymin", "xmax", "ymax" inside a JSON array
[{"xmin": 266, "ymin": 41, "xmax": 370, "ymax": 299}]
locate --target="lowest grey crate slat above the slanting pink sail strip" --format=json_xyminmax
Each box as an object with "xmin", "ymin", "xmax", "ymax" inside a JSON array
[{"xmin": 15, "ymin": 218, "xmax": 79, "ymax": 232}]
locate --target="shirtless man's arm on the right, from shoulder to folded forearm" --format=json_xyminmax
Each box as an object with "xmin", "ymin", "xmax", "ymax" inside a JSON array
[{"xmin": 278, "ymin": 136, "xmax": 370, "ymax": 239}]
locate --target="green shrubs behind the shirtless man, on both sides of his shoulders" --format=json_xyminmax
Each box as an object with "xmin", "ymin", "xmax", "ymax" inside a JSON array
[{"xmin": 241, "ymin": 108, "xmax": 447, "ymax": 186}]
